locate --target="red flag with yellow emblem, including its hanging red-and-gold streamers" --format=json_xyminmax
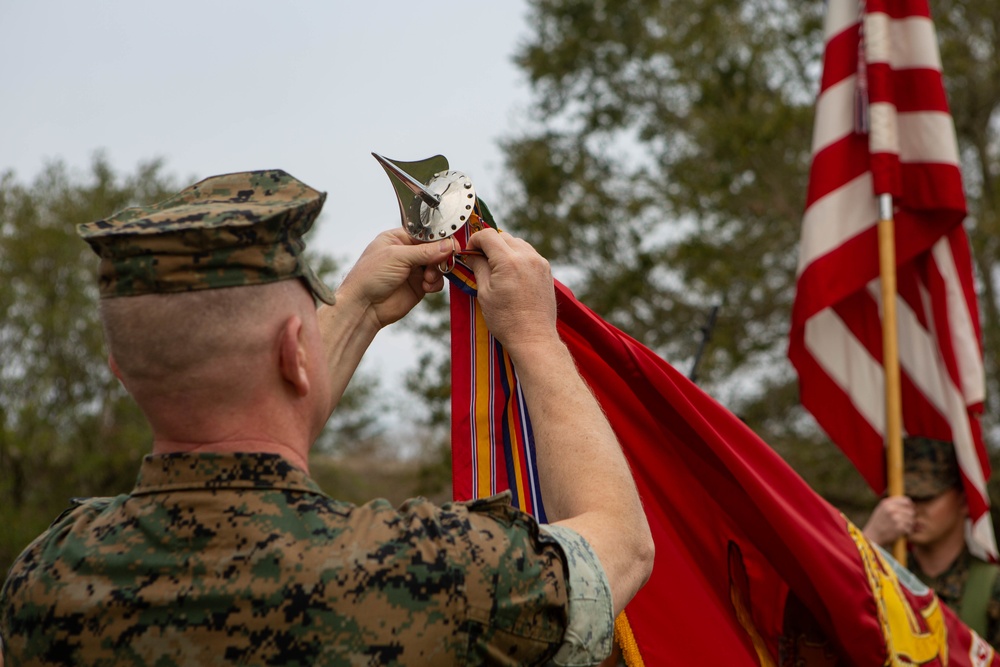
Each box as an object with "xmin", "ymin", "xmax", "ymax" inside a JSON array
[{"xmin": 451, "ymin": 254, "xmax": 994, "ymax": 666}]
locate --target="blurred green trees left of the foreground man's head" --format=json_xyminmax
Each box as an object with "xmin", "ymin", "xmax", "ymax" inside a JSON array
[{"xmin": 0, "ymin": 156, "xmax": 174, "ymax": 571}]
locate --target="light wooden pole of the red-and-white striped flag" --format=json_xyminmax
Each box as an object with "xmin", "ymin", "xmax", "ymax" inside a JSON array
[{"xmin": 878, "ymin": 194, "xmax": 906, "ymax": 567}]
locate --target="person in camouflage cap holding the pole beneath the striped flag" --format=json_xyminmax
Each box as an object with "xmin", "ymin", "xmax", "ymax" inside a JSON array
[{"xmin": 863, "ymin": 437, "xmax": 1000, "ymax": 647}]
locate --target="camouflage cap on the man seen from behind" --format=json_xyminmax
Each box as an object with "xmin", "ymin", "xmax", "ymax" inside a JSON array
[{"xmin": 77, "ymin": 170, "xmax": 334, "ymax": 304}]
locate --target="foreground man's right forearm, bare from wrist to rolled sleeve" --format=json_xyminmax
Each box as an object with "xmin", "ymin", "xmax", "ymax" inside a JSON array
[{"xmin": 512, "ymin": 340, "xmax": 652, "ymax": 612}]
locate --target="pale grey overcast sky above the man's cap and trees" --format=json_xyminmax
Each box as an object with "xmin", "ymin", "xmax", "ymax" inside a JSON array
[{"xmin": 0, "ymin": 0, "xmax": 540, "ymax": 422}]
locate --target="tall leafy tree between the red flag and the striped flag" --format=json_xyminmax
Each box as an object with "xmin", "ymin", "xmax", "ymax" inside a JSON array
[{"xmin": 506, "ymin": 0, "xmax": 822, "ymax": 390}]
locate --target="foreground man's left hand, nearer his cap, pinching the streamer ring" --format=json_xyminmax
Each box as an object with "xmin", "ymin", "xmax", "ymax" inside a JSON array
[{"xmin": 337, "ymin": 229, "xmax": 454, "ymax": 328}]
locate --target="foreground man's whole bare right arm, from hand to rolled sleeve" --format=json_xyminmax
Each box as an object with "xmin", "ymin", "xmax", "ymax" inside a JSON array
[{"xmin": 469, "ymin": 229, "xmax": 653, "ymax": 614}]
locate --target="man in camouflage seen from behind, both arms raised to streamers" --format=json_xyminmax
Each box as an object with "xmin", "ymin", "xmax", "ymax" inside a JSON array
[{"xmin": 0, "ymin": 171, "xmax": 653, "ymax": 667}]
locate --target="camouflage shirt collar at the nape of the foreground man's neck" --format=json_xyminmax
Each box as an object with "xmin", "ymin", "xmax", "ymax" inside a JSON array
[{"xmin": 132, "ymin": 452, "xmax": 325, "ymax": 495}]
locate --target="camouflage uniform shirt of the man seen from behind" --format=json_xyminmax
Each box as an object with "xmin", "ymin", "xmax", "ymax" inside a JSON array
[{"xmin": 0, "ymin": 454, "xmax": 611, "ymax": 667}]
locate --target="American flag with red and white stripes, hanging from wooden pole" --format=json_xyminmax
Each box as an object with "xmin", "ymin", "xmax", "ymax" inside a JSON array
[{"xmin": 788, "ymin": 0, "xmax": 997, "ymax": 559}]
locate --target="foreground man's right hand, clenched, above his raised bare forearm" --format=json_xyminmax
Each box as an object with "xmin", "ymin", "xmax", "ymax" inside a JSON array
[{"xmin": 464, "ymin": 229, "xmax": 559, "ymax": 351}]
